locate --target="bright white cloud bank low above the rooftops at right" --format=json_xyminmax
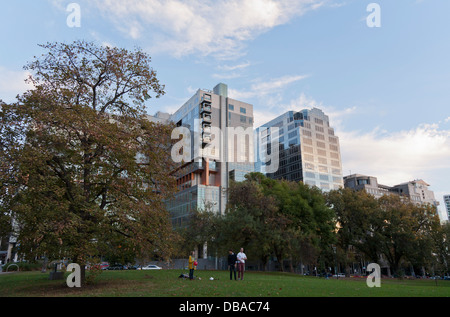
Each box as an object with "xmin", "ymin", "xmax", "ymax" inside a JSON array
[{"xmin": 338, "ymin": 124, "xmax": 450, "ymax": 219}]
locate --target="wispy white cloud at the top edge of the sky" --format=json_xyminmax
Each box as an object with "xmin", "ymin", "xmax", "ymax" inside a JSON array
[{"xmin": 84, "ymin": 0, "xmax": 328, "ymax": 59}]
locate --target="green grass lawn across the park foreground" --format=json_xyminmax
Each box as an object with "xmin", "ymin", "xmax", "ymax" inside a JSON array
[{"xmin": 0, "ymin": 270, "xmax": 450, "ymax": 297}]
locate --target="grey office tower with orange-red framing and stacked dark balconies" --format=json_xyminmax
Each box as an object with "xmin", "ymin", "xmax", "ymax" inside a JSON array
[{"xmin": 149, "ymin": 84, "xmax": 254, "ymax": 227}]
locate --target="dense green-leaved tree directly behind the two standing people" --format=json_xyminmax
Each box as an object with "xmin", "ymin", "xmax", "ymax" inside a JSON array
[{"xmin": 224, "ymin": 173, "xmax": 335, "ymax": 270}]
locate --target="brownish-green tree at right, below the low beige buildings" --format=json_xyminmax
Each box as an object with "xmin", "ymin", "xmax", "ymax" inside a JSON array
[{"xmin": 327, "ymin": 189, "xmax": 442, "ymax": 274}]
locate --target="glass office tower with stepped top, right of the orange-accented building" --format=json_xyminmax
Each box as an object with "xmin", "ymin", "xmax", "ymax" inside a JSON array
[{"xmin": 255, "ymin": 108, "xmax": 344, "ymax": 191}]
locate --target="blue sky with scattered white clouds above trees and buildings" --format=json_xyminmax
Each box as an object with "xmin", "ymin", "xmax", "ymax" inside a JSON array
[{"xmin": 0, "ymin": 0, "xmax": 450, "ymax": 220}]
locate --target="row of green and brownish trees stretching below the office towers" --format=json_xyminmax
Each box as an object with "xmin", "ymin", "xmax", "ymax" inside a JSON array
[{"xmin": 179, "ymin": 173, "xmax": 450, "ymax": 275}]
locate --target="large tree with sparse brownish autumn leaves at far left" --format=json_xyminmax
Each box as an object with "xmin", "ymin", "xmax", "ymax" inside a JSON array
[{"xmin": 1, "ymin": 41, "xmax": 176, "ymax": 278}]
